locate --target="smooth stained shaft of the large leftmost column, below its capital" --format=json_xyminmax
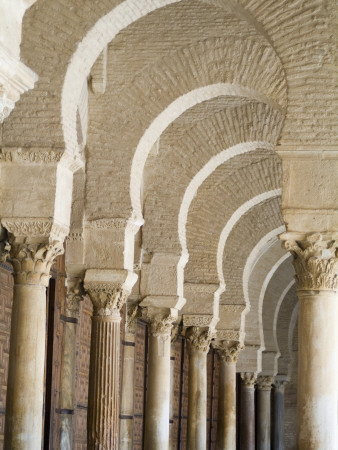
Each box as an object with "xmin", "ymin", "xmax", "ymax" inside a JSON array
[{"xmin": 5, "ymin": 284, "xmax": 46, "ymax": 450}]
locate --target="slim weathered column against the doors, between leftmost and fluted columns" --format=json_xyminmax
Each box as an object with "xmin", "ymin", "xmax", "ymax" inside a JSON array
[{"xmin": 60, "ymin": 278, "xmax": 84, "ymax": 450}]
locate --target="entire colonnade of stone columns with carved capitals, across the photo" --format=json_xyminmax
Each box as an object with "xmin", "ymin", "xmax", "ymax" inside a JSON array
[{"xmin": 1, "ymin": 224, "xmax": 338, "ymax": 450}]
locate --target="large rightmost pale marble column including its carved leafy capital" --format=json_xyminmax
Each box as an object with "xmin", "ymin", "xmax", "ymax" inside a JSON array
[{"xmin": 281, "ymin": 232, "xmax": 338, "ymax": 450}]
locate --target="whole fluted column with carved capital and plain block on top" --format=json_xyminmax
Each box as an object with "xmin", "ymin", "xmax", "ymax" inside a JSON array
[{"xmin": 84, "ymin": 269, "xmax": 135, "ymax": 450}]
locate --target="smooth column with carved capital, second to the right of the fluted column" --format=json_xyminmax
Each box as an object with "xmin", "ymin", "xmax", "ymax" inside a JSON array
[{"xmin": 186, "ymin": 326, "xmax": 213, "ymax": 450}]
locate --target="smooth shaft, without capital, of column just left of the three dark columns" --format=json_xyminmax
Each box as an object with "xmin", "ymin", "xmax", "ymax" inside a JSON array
[{"xmin": 217, "ymin": 358, "xmax": 236, "ymax": 450}]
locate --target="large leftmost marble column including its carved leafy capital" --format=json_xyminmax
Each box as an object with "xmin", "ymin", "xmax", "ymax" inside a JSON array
[{"xmin": 4, "ymin": 222, "xmax": 63, "ymax": 450}]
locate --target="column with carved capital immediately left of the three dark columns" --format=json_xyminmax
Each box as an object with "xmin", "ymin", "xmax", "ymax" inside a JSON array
[{"xmin": 213, "ymin": 340, "xmax": 242, "ymax": 450}]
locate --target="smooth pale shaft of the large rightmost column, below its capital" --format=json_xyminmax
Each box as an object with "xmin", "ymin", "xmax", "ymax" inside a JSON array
[{"xmin": 297, "ymin": 291, "xmax": 338, "ymax": 450}]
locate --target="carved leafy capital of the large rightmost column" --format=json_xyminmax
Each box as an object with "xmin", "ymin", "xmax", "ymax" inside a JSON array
[{"xmin": 280, "ymin": 233, "xmax": 338, "ymax": 291}]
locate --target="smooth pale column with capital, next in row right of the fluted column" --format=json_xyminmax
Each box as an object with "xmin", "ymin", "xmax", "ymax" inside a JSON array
[{"xmin": 144, "ymin": 307, "xmax": 177, "ymax": 450}]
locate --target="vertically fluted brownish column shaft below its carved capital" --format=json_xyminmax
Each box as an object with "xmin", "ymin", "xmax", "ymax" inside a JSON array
[{"xmin": 87, "ymin": 310, "xmax": 121, "ymax": 450}]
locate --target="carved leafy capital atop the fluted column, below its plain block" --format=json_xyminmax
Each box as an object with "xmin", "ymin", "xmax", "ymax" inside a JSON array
[{"xmin": 84, "ymin": 281, "xmax": 130, "ymax": 317}]
